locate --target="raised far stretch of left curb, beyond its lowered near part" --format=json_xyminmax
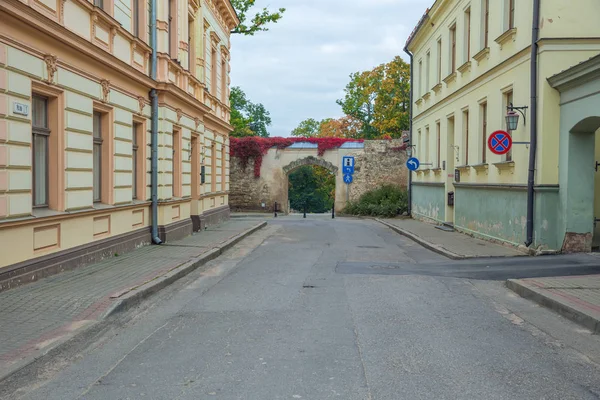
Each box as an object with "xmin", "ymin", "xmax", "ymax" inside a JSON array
[{"xmin": 100, "ymin": 221, "xmax": 267, "ymax": 320}]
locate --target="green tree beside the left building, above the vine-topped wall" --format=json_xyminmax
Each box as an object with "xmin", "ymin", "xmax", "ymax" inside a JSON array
[{"xmin": 229, "ymin": 86, "xmax": 271, "ymax": 137}]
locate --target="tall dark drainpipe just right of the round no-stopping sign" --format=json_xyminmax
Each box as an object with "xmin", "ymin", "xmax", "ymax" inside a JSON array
[{"xmin": 525, "ymin": 0, "xmax": 541, "ymax": 247}]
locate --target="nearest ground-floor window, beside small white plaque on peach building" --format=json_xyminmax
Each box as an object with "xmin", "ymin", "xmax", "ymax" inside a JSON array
[{"xmin": 31, "ymin": 94, "xmax": 50, "ymax": 207}]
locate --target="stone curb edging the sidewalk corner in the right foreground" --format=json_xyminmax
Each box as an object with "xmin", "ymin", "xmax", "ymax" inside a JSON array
[{"xmin": 506, "ymin": 279, "xmax": 600, "ymax": 333}]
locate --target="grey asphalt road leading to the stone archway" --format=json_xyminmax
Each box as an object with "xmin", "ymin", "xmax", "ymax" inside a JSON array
[{"xmin": 0, "ymin": 216, "xmax": 600, "ymax": 400}]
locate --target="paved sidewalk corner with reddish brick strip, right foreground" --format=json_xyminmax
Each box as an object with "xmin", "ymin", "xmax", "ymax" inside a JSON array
[{"xmin": 506, "ymin": 275, "xmax": 600, "ymax": 333}]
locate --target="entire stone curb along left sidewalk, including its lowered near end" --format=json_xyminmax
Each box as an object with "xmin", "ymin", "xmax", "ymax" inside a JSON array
[{"xmin": 0, "ymin": 221, "xmax": 267, "ymax": 383}]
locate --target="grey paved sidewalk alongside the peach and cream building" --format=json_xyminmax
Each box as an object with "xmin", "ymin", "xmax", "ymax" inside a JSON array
[{"xmin": 0, "ymin": 220, "xmax": 266, "ymax": 380}]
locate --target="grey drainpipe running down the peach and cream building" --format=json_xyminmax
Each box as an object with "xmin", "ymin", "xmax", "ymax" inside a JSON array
[{"xmin": 150, "ymin": 0, "xmax": 162, "ymax": 244}]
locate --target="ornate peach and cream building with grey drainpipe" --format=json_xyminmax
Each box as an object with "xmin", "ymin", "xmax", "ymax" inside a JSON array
[{"xmin": 0, "ymin": 0, "xmax": 239, "ymax": 289}]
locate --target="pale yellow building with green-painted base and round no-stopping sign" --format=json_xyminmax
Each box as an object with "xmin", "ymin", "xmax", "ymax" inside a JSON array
[{"xmin": 406, "ymin": 0, "xmax": 600, "ymax": 251}]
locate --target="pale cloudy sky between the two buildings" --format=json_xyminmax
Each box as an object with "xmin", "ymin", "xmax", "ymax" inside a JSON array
[{"xmin": 231, "ymin": 0, "xmax": 433, "ymax": 136}]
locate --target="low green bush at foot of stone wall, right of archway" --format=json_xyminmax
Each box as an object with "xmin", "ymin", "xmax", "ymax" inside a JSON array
[{"xmin": 344, "ymin": 185, "xmax": 408, "ymax": 218}]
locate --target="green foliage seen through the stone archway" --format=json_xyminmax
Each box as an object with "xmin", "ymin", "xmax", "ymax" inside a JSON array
[{"xmin": 289, "ymin": 165, "xmax": 335, "ymax": 213}]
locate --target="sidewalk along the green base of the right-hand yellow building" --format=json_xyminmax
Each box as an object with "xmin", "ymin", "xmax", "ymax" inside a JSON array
[{"xmin": 377, "ymin": 218, "xmax": 526, "ymax": 260}]
